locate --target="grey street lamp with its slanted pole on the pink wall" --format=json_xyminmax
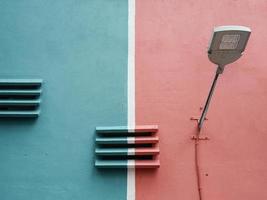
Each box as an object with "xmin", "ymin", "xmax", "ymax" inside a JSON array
[{"xmin": 198, "ymin": 26, "xmax": 251, "ymax": 130}]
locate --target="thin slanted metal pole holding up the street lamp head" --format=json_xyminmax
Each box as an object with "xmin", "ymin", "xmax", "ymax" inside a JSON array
[{"xmin": 198, "ymin": 66, "xmax": 224, "ymax": 130}]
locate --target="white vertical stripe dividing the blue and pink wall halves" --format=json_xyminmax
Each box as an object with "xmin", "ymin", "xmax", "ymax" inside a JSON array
[{"xmin": 127, "ymin": 0, "xmax": 135, "ymax": 200}]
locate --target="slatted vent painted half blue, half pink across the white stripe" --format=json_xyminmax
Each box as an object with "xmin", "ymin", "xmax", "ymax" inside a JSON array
[{"xmin": 95, "ymin": 125, "xmax": 160, "ymax": 168}]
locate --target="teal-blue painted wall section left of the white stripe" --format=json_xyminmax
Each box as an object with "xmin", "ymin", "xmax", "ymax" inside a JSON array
[{"xmin": 0, "ymin": 0, "xmax": 128, "ymax": 200}]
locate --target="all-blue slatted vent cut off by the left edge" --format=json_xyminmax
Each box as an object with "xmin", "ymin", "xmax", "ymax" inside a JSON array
[{"xmin": 0, "ymin": 79, "xmax": 43, "ymax": 118}]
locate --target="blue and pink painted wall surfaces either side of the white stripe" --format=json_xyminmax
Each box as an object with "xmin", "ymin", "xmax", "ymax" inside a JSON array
[{"xmin": 0, "ymin": 0, "xmax": 267, "ymax": 200}]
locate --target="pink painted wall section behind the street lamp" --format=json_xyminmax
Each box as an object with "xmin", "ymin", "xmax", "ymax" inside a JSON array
[{"xmin": 136, "ymin": 0, "xmax": 267, "ymax": 200}]
